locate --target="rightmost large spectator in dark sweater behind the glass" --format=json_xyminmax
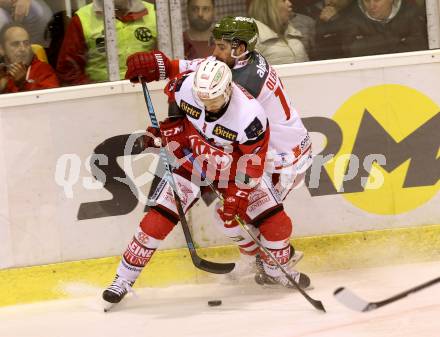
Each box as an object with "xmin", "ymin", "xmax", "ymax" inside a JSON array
[{"xmin": 344, "ymin": 0, "xmax": 428, "ymax": 56}]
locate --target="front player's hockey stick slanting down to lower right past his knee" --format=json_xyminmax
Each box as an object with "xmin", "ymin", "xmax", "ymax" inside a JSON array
[{"xmin": 183, "ymin": 149, "xmax": 326, "ymax": 312}]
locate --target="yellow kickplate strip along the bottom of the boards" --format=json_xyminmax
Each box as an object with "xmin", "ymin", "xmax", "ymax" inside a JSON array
[{"xmin": 0, "ymin": 226, "xmax": 440, "ymax": 307}]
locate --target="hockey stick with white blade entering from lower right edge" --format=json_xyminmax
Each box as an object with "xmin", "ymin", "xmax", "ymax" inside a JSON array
[{"xmin": 333, "ymin": 277, "xmax": 440, "ymax": 312}]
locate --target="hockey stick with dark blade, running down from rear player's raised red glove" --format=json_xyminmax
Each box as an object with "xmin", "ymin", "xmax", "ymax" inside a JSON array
[{"xmin": 139, "ymin": 78, "xmax": 235, "ymax": 274}]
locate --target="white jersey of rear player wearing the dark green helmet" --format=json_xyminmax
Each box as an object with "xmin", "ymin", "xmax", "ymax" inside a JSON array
[{"xmin": 174, "ymin": 52, "xmax": 311, "ymax": 172}]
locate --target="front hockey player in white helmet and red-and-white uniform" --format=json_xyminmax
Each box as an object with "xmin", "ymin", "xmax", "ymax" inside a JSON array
[{"xmin": 103, "ymin": 60, "xmax": 310, "ymax": 306}]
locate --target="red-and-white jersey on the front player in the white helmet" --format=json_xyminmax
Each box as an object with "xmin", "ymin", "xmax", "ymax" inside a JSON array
[{"xmin": 166, "ymin": 72, "xmax": 269, "ymax": 181}]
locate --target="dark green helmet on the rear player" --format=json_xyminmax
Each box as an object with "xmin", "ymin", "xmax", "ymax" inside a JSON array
[{"xmin": 212, "ymin": 16, "xmax": 258, "ymax": 52}]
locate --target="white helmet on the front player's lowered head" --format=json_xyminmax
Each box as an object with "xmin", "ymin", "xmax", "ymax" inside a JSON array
[{"xmin": 193, "ymin": 60, "xmax": 232, "ymax": 104}]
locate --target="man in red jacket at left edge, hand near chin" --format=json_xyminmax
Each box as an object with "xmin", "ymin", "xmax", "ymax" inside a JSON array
[{"xmin": 0, "ymin": 23, "xmax": 59, "ymax": 93}]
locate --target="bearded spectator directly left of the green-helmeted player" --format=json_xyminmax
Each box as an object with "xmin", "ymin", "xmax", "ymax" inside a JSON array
[{"xmin": 183, "ymin": 0, "xmax": 215, "ymax": 60}]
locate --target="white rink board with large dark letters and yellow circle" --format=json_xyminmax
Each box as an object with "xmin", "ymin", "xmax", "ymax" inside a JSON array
[{"xmin": 0, "ymin": 51, "xmax": 440, "ymax": 304}]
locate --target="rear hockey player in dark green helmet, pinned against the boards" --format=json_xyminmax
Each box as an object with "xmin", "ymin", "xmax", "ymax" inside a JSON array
[{"xmin": 126, "ymin": 17, "xmax": 312, "ymax": 283}]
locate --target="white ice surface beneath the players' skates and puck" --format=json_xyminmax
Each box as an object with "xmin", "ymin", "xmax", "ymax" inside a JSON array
[{"xmin": 0, "ymin": 262, "xmax": 440, "ymax": 337}]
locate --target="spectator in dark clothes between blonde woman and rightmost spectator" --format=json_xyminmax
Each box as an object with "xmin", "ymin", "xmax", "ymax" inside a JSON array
[{"xmin": 314, "ymin": 0, "xmax": 356, "ymax": 60}]
